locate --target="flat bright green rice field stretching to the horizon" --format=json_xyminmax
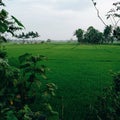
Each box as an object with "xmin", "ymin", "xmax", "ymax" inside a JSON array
[{"xmin": 6, "ymin": 44, "xmax": 120, "ymax": 120}]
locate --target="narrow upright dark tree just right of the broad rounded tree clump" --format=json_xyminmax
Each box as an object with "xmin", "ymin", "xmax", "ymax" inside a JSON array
[{"xmin": 103, "ymin": 25, "xmax": 113, "ymax": 43}]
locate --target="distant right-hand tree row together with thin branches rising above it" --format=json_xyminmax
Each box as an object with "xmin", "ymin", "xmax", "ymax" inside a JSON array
[{"xmin": 74, "ymin": 0, "xmax": 120, "ymax": 44}]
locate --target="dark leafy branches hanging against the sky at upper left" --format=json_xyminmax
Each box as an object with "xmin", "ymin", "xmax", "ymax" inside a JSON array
[{"xmin": 0, "ymin": 1, "xmax": 24, "ymax": 42}]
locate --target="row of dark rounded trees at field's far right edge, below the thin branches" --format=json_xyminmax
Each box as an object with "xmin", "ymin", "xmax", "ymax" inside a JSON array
[{"xmin": 74, "ymin": 25, "xmax": 120, "ymax": 44}]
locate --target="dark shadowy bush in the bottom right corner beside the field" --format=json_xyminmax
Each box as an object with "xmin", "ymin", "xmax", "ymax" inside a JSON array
[{"xmin": 86, "ymin": 72, "xmax": 120, "ymax": 120}]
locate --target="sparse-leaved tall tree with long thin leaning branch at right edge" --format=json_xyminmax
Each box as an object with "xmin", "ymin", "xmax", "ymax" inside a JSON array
[{"xmin": 91, "ymin": 0, "xmax": 120, "ymax": 41}]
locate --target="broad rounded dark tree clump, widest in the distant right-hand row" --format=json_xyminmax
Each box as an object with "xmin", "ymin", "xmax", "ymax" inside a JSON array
[{"xmin": 84, "ymin": 26, "xmax": 103, "ymax": 44}]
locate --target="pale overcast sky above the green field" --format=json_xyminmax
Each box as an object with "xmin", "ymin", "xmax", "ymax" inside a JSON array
[{"xmin": 4, "ymin": 0, "xmax": 117, "ymax": 40}]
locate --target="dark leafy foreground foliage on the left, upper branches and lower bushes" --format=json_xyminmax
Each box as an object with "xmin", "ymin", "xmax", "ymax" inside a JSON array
[{"xmin": 0, "ymin": 1, "xmax": 58, "ymax": 120}]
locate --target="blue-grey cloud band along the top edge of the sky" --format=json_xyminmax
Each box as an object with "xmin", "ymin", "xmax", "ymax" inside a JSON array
[{"xmin": 11, "ymin": 0, "xmax": 91, "ymax": 11}]
